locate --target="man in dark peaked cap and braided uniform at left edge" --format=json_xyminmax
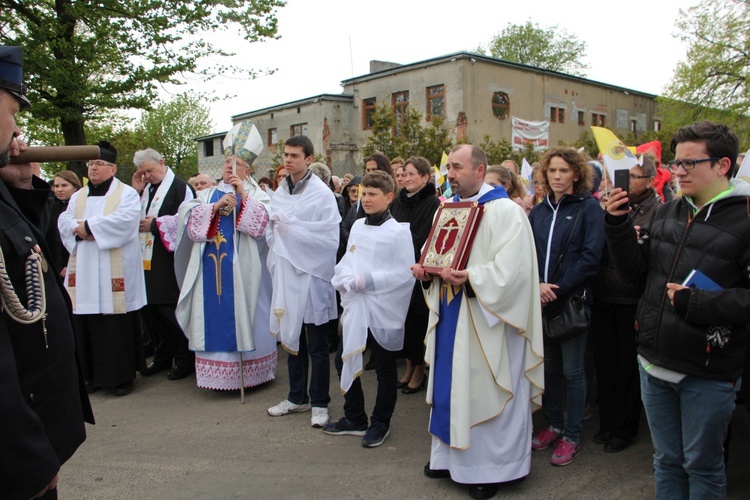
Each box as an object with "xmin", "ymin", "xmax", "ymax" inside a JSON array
[{"xmin": 0, "ymin": 47, "xmax": 93, "ymax": 498}]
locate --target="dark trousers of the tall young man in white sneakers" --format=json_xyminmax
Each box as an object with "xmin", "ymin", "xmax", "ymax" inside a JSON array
[{"xmin": 287, "ymin": 323, "xmax": 331, "ymax": 408}]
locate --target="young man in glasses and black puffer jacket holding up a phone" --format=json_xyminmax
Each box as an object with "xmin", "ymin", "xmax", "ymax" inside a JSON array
[{"xmin": 605, "ymin": 121, "xmax": 750, "ymax": 499}]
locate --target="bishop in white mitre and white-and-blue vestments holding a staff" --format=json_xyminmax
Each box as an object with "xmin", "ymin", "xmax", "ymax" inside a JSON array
[{"xmin": 175, "ymin": 121, "xmax": 277, "ymax": 390}]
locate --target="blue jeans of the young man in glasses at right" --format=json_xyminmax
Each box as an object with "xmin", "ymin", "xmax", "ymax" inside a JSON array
[{"xmin": 640, "ymin": 367, "xmax": 734, "ymax": 500}]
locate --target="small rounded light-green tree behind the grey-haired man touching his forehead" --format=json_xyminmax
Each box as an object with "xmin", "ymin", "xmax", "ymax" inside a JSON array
[{"xmin": 137, "ymin": 94, "xmax": 213, "ymax": 179}]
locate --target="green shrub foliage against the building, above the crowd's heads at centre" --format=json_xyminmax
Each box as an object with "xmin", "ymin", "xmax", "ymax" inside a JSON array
[{"xmin": 363, "ymin": 104, "xmax": 453, "ymax": 165}]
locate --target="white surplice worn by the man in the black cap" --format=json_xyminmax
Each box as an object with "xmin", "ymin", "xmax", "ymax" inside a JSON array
[{"xmin": 57, "ymin": 178, "xmax": 146, "ymax": 314}]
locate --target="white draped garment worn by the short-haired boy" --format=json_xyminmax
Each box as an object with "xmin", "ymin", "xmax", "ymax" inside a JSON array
[{"xmin": 332, "ymin": 219, "xmax": 414, "ymax": 392}]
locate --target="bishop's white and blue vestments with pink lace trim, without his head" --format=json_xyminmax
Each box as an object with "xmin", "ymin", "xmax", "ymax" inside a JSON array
[{"xmin": 175, "ymin": 177, "xmax": 277, "ymax": 390}]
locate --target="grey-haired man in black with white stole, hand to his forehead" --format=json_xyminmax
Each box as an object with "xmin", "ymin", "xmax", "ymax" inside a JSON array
[{"xmin": 133, "ymin": 149, "xmax": 195, "ymax": 380}]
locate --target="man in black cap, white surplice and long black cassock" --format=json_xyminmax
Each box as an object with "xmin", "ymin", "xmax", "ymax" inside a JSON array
[{"xmin": 58, "ymin": 141, "xmax": 146, "ymax": 396}]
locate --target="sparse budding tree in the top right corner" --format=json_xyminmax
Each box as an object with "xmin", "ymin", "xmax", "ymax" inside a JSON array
[{"xmin": 659, "ymin": 0, "xmax": 750, "ymax": 143}]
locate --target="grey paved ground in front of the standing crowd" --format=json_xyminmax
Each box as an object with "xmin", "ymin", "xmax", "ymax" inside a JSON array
[{"xmin": 59, "ymin": 352, "xmax": 750, "ymax": 500}]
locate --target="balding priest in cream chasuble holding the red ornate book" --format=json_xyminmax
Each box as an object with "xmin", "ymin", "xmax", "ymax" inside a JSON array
[{"xmin": 413, "ymin": 145, "xmax": 544, "ymax": 498}]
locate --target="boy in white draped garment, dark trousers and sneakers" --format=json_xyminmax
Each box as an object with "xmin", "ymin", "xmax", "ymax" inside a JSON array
[{"xmin": 323, "ymin": 170, "xmax": 414, "ymax": 448}]
